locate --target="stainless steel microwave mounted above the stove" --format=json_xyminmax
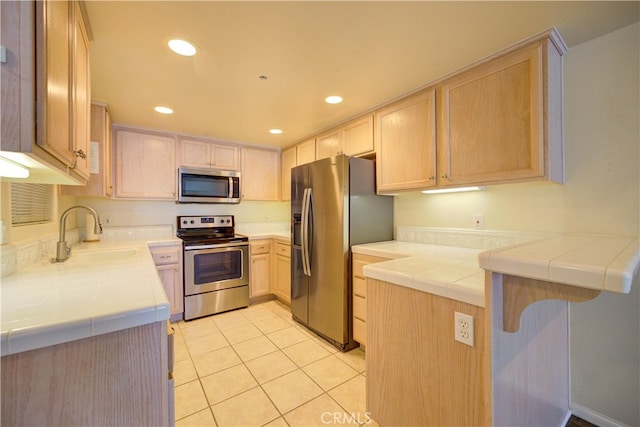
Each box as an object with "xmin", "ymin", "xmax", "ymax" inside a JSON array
[{"xmin": 177, "ymin": 167, "xmax": 240, "ymax": 203}]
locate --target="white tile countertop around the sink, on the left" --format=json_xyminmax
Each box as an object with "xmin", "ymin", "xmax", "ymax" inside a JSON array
[{"xmin": 0, "ymin": 238, "xmax": 175, "ymax": 356}]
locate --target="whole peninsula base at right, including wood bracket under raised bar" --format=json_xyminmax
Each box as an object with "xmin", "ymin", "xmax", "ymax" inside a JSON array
[{"xmin": 367, "ymin": 272, "xmax": 572, "ymax": 426}]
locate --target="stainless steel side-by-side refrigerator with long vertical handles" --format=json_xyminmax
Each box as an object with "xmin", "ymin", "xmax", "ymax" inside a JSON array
[{"xmin": 291, "ymin": 155, "xmax": 393, "ymax": 351}]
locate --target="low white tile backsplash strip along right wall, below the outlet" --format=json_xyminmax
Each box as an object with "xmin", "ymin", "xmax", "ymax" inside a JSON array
[{"xmin": 396, "ymin": 226, "xmax": 550, "ymax": 250}]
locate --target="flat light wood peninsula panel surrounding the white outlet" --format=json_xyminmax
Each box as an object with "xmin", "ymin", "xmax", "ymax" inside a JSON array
[{"xmin": 367, "ymin": 279, "xmax": 488, "ymax": 426}]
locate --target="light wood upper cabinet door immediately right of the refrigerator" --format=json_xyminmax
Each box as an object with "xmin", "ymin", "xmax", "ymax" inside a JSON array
[{"xmin": 375, "ymin": 89, "xmax": 436, "ymax": 193}]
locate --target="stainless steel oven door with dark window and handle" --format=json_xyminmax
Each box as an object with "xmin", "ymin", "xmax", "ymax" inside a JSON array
[{"xmin": 184, "ymin": 242, "xmax": 249, "ymax": 295}]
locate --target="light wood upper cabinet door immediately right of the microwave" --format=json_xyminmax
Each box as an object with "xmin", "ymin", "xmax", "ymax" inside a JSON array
[{"xmin": 240, "ymin": 147, "xmax": 280, "ymax": 201}]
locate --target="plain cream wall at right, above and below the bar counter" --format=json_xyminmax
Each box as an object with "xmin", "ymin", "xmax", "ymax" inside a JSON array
[{"xmin": 395, "ymin": 23, "xmax": 640, "ymax": 425}]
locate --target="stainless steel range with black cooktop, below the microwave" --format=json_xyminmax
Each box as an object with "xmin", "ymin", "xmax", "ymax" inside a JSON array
[{"xmin": 177, "ymin": 215, "xmax": 249, "ymax": 320}]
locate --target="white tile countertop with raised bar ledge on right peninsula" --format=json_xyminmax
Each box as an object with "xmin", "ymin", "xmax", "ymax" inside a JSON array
[{"xmin": 352, "ymin": 235, "xmax": 640, "ymax": 307}]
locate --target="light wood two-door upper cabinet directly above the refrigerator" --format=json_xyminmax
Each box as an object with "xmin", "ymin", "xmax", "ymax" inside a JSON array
[{"xmin": 316, "ymin": 114, "xmax": 375, "ymax": 159}]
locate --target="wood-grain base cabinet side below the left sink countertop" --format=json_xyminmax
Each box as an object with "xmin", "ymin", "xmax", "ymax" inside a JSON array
[{"xmin": 0, "ymin": 321, "xmax": 173, "ymax": 426}]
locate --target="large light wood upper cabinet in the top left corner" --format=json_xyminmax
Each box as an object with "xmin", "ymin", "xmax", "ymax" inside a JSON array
[{"xmin": 0, "ymin": 1, "xmax": 91, "ymax": 185}]
